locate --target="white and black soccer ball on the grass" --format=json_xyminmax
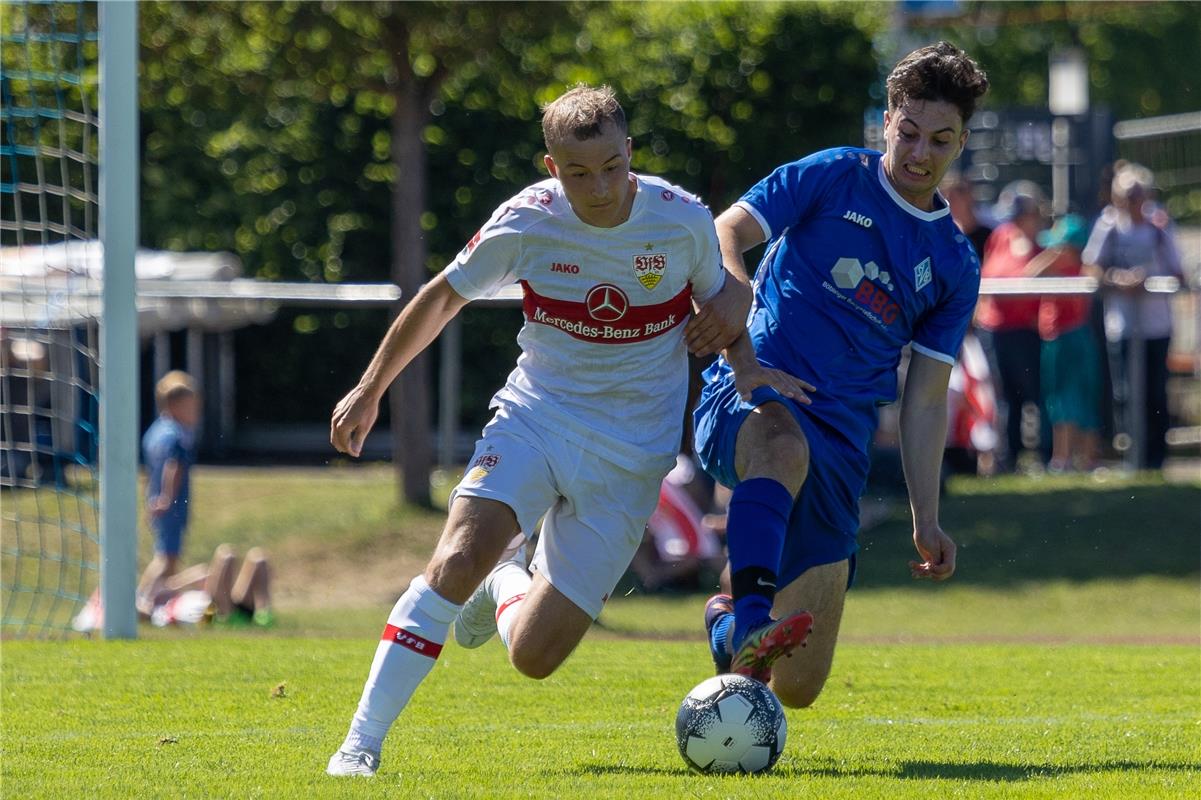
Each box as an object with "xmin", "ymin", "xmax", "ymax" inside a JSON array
[{"xmin": 676, "ymin": 675, "xmax": 788, "ymax": 772}]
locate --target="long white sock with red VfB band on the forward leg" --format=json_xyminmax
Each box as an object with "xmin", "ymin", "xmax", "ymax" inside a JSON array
[{"xmin": 342, "ymin": 575, "xmax": 462, "ymax": 753}]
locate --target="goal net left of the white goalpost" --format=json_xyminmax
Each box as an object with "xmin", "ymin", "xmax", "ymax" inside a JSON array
[{"xmin": 0, "ymin": 0, "xmax": 126, "ymax": 638}]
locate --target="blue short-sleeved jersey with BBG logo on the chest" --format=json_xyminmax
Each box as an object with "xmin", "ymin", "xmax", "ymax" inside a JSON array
[{"xmin": 707, "ymin": 148, "xmax": 980, "ymax": 452}]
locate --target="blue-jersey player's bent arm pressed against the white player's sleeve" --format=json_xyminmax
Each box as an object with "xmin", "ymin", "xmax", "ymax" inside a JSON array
[{"xmin": 683, "ymin": 205, "xmax": 764, "ymax": 357}]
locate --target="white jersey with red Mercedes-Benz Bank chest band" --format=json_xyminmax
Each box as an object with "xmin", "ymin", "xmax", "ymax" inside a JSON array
[{"xmin": 446, "ymin": 175, "xmax": 724, "ymax": 471}]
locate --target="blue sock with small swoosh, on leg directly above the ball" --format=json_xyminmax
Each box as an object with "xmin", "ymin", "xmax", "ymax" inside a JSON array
[{"xmin": 715, "ymin": 478, "xmax": 793, "ymax": 649}]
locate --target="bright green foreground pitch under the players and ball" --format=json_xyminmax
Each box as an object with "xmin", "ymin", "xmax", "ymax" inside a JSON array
[{"xmin": 2, "ymin": 634, "xmax": 1201, "ymax": 800}]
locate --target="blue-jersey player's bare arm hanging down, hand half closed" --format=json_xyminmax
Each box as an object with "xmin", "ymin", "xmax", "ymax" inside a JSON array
[{"xmin": 901, "ymin": 352, "xmax": 955, "ymax": 580}]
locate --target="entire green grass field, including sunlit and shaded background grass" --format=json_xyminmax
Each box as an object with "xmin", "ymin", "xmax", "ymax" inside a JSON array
[{"xmin": 0, "ymin": 470, "xmax": 1201, "ymax": 800}]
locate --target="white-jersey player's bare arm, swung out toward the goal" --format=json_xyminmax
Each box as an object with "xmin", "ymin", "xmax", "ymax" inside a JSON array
[{"xmin": 329, "ymin": 273, "xmax": 467, "ymax": 458}]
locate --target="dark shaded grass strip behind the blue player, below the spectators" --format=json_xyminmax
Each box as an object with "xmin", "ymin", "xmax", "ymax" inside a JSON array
[{"xmin": 855, "ymin": 475, "xmax": 1201, "ymax": 586}]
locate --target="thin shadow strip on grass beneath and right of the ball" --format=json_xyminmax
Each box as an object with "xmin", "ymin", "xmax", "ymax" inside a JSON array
[{"xmin": 575, "ymin": 762, "xmax": 1201, "ymax": 783}]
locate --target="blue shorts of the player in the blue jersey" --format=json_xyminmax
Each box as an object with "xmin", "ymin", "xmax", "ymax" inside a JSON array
[{"xmin": 693, "ymin": 371, "xmax": 871, "ymax": 586}]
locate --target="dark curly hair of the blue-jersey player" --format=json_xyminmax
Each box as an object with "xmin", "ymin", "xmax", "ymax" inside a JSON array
[{"xmin": 885, "ymin": 42, "xmax": 988, "ymax": 125}]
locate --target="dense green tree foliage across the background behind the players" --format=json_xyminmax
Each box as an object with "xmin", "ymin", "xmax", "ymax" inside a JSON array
[{"xmin": 133, "ymin": 0, "xmax": 1201, "ymax": 468}]
